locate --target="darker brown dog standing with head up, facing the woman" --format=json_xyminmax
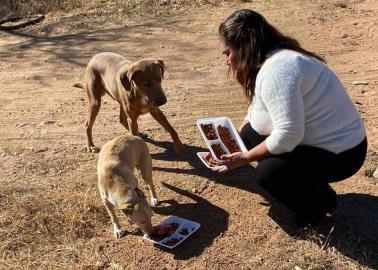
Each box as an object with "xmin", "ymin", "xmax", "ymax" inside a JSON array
[{"xmin": 74, "ymin": 52, "xmax": 183, "ymax": 154}]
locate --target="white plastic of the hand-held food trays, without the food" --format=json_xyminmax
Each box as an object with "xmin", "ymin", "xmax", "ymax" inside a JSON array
[{"xmin": 197, "ymin": 117, "xmax": 248, "ymax": 162}]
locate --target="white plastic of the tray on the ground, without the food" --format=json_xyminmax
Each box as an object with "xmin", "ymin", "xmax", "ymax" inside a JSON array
[{"xmin": 143, "ymin": 216, "xmax": 201, "ymax": 249}]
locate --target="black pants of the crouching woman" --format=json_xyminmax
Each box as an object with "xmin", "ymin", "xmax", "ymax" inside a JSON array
[{"xmin": 240, "ymin": 124, "xmax": 367, "ymax": 217}]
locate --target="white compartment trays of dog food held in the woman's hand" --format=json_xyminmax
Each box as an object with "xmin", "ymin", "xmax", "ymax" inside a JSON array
[{"xmin": 197, "ymin": 117, "xmax": 247, "ymax": 162}]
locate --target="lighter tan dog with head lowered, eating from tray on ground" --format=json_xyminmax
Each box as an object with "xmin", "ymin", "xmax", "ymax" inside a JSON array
[{"xmin": 97, "ymin": 134, "xmax": 158, "ymax": 238}]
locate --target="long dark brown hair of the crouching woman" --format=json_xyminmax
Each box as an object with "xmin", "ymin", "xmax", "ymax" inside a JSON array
[{"xmin": 219, "ymin": 9, "xmax": 325, "ymax": 102}]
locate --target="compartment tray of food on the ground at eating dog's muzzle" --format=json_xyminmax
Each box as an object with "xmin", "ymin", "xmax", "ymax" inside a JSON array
[{"xmin": 143, "ymin": 216, "xmax": 201, "ymax": 249}]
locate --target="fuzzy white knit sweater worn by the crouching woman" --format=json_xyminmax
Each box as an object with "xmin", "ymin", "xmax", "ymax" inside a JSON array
[{"xmin": 245, "ymin": 50, "xmax": 365, "ymax": 154}]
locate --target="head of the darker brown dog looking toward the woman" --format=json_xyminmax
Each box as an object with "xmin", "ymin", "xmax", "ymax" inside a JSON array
[{"xmin": 120, "ymin": 59, "xmax": 167, "ymax": 106}]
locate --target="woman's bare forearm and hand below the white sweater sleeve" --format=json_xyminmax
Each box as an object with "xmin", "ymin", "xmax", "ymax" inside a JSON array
[{"xmin": 218, "ymin": 141, "xmax": 271, "ymax": 173}]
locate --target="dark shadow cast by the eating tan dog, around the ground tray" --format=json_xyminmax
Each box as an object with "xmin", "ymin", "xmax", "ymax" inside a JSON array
[{"xmin": 154, "ymin": 182, "xmax": 229, "ymax": 260}]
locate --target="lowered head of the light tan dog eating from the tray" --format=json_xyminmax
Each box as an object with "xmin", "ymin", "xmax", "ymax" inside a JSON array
[{"xmin": 117, "ymin": 188, "xmax": 152, "ymax": 234}]
